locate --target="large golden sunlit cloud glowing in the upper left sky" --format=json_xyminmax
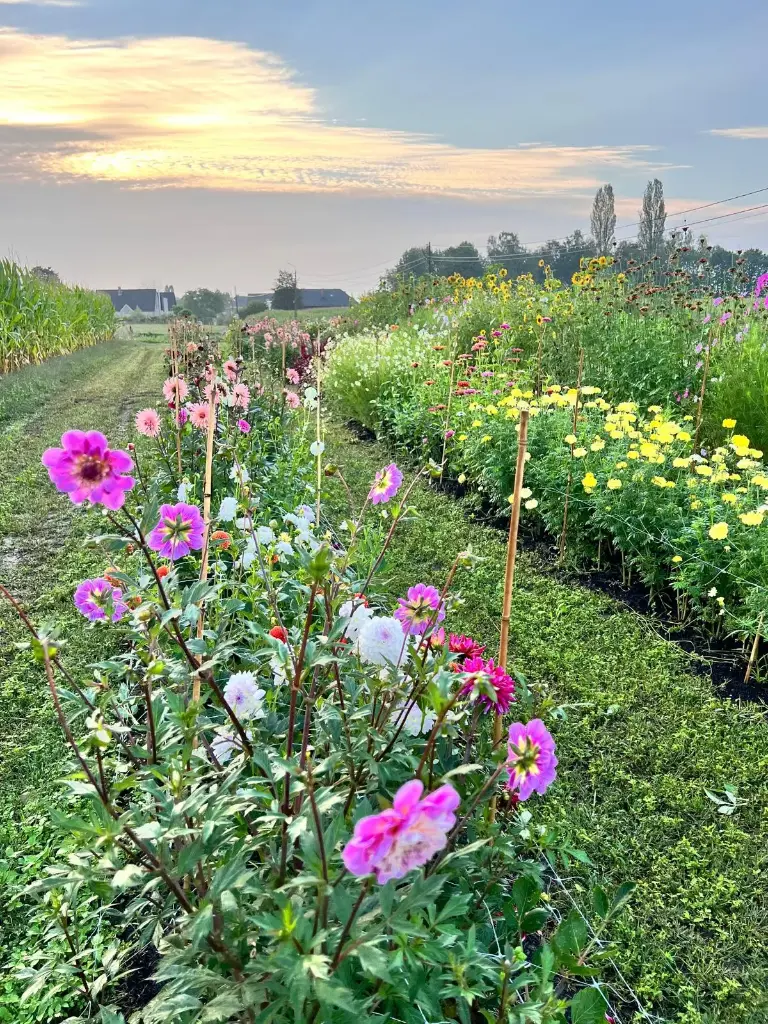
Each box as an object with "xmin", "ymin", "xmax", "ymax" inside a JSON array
[{"xmin": 0, "ymin": 28, "xmax": 671, "ymax": 199}]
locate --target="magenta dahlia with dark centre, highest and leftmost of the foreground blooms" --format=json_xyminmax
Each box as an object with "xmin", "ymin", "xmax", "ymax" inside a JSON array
[{"xmin": 42, "ymin": 430, "xmax": 136, "ymax": 512}]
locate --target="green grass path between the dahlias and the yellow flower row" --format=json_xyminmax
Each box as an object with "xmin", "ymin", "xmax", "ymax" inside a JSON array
[{"xmin": 326, "ymin": 417, "xmax": 768, "ymax": 1024}]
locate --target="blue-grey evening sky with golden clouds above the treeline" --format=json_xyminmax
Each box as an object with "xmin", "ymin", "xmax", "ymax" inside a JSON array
[{"xmin": 0, "ymin": 0, "xmax": 768, "ymax": 295}]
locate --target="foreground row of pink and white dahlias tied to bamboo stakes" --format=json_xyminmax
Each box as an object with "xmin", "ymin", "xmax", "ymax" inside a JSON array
[{"xmin": 1, "ymin": 349, "xmax": 631, "ymax": 1024}]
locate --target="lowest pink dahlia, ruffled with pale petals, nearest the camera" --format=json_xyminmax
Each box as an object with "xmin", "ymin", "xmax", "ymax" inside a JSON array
[{"xmin": 342, "ymin": 778, "xmax": 461, "ymax": 886}]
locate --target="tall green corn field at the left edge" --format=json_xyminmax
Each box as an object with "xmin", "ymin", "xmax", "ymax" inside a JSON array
[{"xmin": 0, "ymin": 260, "xmax": 115, "ymax": 374}]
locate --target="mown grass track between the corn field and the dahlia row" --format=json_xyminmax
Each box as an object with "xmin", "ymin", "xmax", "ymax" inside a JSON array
[{"xmin": 0, "ymin": 341, "xmax": 163, "ymax": 1007}]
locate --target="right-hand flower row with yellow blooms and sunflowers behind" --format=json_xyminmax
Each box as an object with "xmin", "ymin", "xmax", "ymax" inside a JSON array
[{"xmin": 325, "ymin": 265, "xmax": 768, "ymax": 637}]
